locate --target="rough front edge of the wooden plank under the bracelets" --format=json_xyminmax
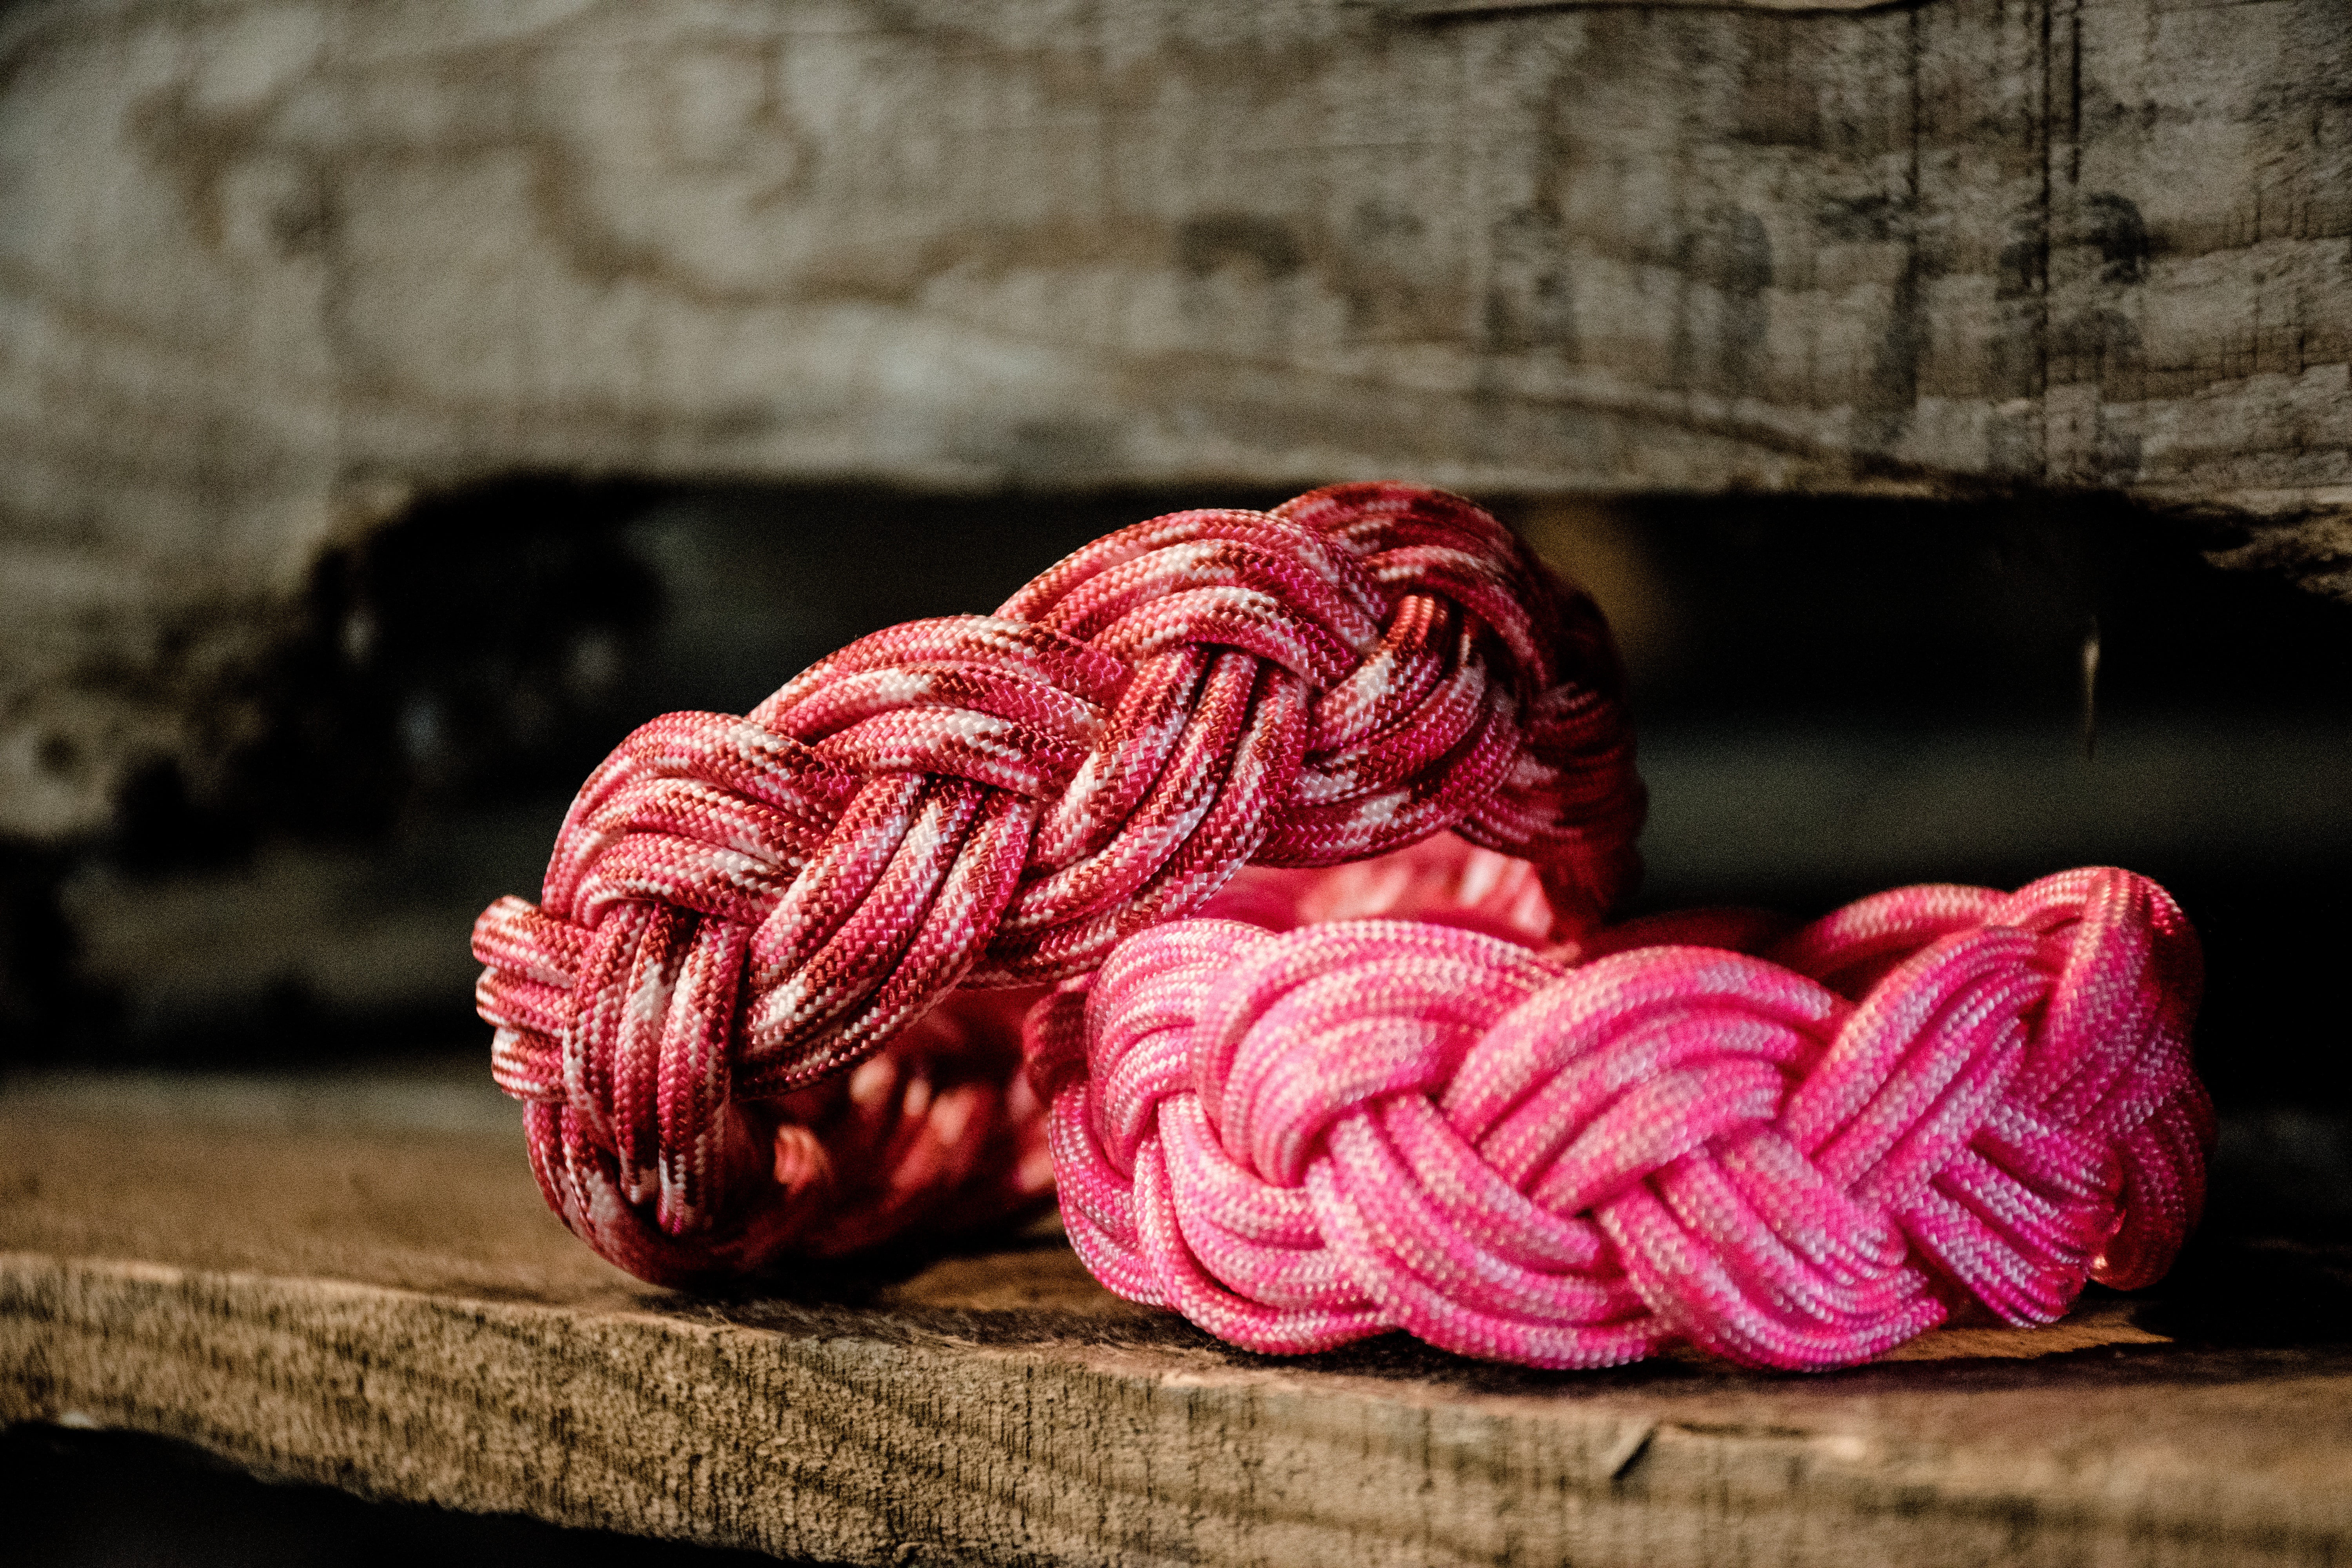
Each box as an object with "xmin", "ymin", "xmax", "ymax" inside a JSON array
[{"xmin": 0, "ymin": 1253, "xmax": 2347, "ymax": 1563}]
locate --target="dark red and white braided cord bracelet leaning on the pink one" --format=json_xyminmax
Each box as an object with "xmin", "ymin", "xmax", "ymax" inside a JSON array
[{"xmin": 459, "ymin": 484, "xmax": 1642, "ymax": 1281}]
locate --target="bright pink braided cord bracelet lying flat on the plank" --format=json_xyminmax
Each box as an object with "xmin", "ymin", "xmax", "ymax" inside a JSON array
[{"xmin": 1028, "ymin": 867, "xmax": 2213, "ymax": 1368}]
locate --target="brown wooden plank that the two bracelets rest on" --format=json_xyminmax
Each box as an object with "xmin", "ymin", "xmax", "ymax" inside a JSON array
[{"xmin": 0, "ymin": 1077, "xmax": 2352, "ymax": 1568}]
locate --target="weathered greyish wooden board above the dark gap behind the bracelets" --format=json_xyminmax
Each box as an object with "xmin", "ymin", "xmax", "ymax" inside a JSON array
[{"xmin": 0, "ymin": 0, "xmax": 2352, "ymax": 839}]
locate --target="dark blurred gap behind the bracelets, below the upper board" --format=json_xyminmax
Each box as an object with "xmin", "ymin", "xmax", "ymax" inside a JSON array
[{"xmin": 0, "ymin": 477, "xmax": 2352, "ymax": 1227}]
